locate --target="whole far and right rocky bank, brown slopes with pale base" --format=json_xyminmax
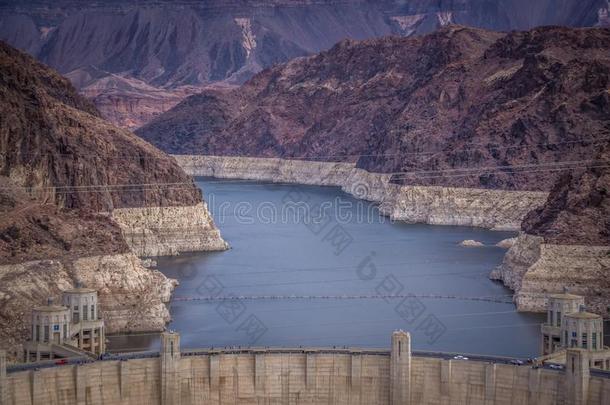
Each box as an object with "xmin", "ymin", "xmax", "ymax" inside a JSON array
[{"xmin": 138, "ymin": 26, "xmax": 610, "ymax": 312}]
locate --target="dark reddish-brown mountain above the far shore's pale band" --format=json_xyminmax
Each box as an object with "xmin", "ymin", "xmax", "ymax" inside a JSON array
[{"xmin": 137, "ymin": 26, "xmax": 610, "ymax": 191}]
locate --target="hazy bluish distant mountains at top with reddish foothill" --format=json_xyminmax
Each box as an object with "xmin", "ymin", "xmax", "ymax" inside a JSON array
[{"xmin": 0, "ymin": 0, "xmax": 609, "ymax": 128}]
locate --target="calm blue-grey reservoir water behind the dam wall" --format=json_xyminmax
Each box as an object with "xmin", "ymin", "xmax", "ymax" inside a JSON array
[{"xmin": 111, "ymin": 179, "xmax": 544, "ymax": 357}]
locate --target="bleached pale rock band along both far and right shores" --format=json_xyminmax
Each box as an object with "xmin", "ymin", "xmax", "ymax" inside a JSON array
[{"xmin": 174, "ymin": 155, "xmax": 610, "ymax": 314}]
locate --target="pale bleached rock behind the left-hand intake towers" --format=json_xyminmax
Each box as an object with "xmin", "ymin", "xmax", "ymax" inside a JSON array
[{"xmin": 0, "ymin": 253, "xmax": 177, "ymax": 348}]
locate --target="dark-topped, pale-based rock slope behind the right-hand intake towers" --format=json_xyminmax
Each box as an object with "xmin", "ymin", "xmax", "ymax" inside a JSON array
[{"xmin": 492, "ymin": 142, "xmax": 610, "ymax": 315}]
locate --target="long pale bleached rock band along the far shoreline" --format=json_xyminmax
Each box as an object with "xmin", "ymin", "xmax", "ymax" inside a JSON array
[{"xmin": 174, "ymin": 155, "xmax": 548, "ymax": 230}]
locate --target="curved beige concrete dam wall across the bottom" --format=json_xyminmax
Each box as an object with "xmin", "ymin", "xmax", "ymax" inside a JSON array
[{"xmin": 0, "ymin": 331, "xmax": 610, "ymax": 405}]
